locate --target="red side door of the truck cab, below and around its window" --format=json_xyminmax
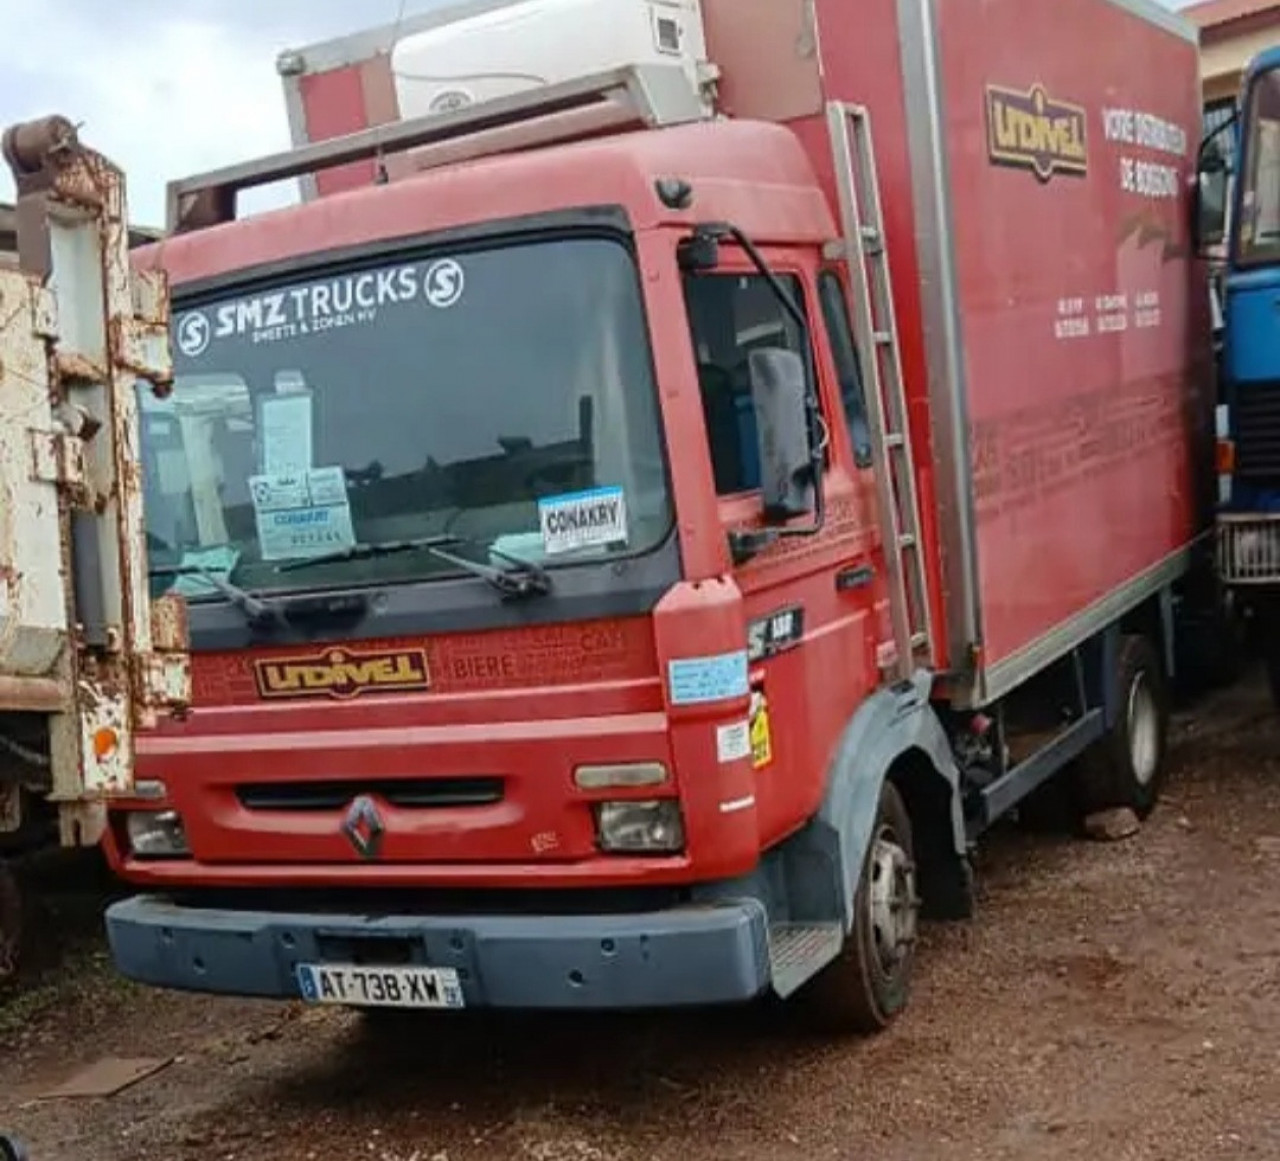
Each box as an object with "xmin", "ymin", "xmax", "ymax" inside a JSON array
[{"xmin": 684, "ymin": 250, "xmax": 882, "ymax": 844}]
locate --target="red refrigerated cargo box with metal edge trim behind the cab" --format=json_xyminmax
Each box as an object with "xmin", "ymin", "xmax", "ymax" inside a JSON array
[{"xmin": 282, "ymin": 0, "xmax": 1212, "ymax": 704}]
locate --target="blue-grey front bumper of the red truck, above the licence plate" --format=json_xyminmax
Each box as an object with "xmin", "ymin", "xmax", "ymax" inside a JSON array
[{"xmin": 106, "ymin": 895, "xmax": 769, "ymax": 1009}]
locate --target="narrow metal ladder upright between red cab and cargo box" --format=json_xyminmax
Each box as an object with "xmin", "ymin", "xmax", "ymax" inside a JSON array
[{"xmin": 827, "ymin": 101, "xmax": 933, "ymax": 681}]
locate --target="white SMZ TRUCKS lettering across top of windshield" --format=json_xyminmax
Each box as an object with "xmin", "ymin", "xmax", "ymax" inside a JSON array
[{"xmin": 174, "ymin": 259, "xmax": 466, "ymax": 360}]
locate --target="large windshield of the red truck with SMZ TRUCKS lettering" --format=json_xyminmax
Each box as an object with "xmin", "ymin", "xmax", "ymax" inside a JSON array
[{"xmin": 141, "ymin": 237, "xmax": 672, "ymax": 597}]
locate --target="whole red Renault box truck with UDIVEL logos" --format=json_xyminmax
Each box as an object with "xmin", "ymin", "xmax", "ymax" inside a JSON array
[{"xmin": 106, "ymin": 0, "xmax": 1212, "ymax": 1030}]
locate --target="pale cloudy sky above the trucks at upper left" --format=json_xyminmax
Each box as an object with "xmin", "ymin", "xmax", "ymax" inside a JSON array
[{"xmin": 0, "ymin": 0, "xmax": 1187, "ymax": 225}]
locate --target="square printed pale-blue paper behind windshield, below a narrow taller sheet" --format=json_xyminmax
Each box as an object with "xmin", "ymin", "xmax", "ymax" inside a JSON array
[{"xmin": 250, "ymin": 467, "xmax": 356, "ymax": 561}]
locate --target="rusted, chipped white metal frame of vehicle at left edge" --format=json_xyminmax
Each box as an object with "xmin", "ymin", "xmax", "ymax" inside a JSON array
[{"xmin": 0, "ymin": 118, "xmax": 191, "ymax": 842}]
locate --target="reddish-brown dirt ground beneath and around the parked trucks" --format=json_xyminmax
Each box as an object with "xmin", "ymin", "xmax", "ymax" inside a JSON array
[{"xmin": 0, "ymin": 684, "xmax": 1280, "ymax": 1161}]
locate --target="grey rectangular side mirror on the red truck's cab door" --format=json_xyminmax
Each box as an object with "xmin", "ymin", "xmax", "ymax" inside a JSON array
[{"xmin": 748, "ymin": 347, "xmax": 814, "ymax": 524}]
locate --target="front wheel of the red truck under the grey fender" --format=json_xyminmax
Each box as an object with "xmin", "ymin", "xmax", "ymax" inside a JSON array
[{"xmin": 803, "ymin": 781, "xmax": 920, "ymax": 1034}]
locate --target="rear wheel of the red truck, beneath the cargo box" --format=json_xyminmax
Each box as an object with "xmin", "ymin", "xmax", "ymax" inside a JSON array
[{"xmin": 1076, "ymin": 635, "xmax": 1169, "ymax": 818}]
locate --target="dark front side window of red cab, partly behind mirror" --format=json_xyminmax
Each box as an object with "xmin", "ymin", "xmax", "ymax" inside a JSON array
[{"xmin": 685, "ymin": 274, "xmax": 812, "ymax": 495}]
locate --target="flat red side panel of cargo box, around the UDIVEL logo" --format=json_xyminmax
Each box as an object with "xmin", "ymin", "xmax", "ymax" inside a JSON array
[{"xmin": 941, "ymin": 0, "xmax": 1210, "ymax": 663}]
